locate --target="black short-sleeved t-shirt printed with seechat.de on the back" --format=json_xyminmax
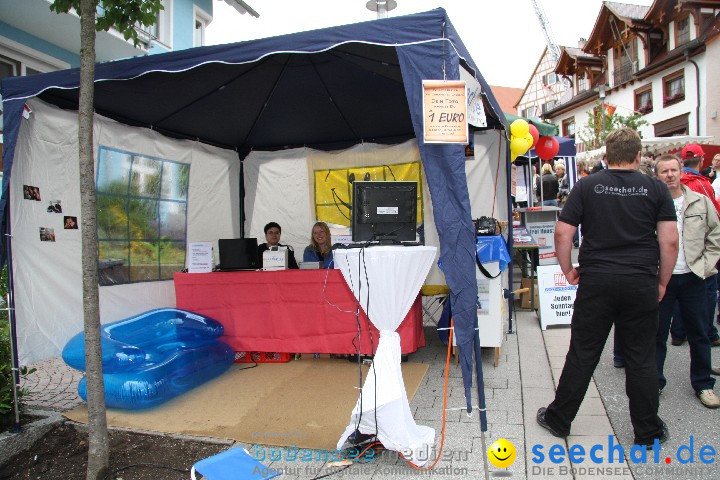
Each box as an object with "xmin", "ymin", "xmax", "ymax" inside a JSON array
[{"xmin": 560, "ymin": 169, "xmax": 676, "ymax": 275}]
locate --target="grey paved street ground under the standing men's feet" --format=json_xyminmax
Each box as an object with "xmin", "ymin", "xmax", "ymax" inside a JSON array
[{"xmin": 16, "ymin": 311, "xmax": 720, "ymax": 480}]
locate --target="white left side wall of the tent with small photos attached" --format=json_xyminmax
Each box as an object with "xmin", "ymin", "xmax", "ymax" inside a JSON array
[{"xmin": 10, "ymin": 99, "xmax": 240, "ymax": 364}]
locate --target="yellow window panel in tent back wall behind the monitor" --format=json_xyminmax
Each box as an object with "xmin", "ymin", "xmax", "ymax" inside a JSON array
[{"xmin": 315, "ymin": 162, "xmax": 423, "ymax": 227}]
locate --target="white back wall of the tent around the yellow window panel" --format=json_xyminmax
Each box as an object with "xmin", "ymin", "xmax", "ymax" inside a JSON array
[{"xmin": 243, "ymin": 131, "xmax": 508, "ymax": 285}]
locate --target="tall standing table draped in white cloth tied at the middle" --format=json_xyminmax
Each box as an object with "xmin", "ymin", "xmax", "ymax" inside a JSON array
[{"xmin": 334, "ymin": 246, "xmax": 436, "ymax": 466}]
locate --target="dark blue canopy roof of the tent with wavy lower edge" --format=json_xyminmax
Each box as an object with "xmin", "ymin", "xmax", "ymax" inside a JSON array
[{"xmin": 2, "ymin": 9, "xmax": 505, "ymax": 150}]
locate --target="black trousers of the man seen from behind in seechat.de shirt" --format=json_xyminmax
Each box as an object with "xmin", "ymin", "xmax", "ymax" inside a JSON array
[{"xmin": 545, "ymin": 274, "xmax": 662, "ymax": 441}]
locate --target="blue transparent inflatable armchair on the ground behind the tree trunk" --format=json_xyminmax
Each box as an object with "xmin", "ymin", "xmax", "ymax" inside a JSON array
[{"xmin": 62, "ymin": 308, "xmax": 234, "ymax": 410}]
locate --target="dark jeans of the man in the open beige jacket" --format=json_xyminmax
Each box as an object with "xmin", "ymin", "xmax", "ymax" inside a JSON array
[{"xmin": 656, "ymin": 273, "xmax": 715, "ymax": 392}]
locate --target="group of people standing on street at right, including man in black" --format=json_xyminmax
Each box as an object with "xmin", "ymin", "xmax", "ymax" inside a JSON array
[{"xmin": 536, "ymin": 128, "xmax": 720, "ymax": 449}]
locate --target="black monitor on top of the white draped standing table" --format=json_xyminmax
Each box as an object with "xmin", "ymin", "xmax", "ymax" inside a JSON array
[{"xmin": 352, "ymin": 182, "xmax": 417, "ymax": 243}]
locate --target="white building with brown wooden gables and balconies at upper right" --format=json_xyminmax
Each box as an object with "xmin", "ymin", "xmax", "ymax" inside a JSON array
[{"xmin": 543, "ymin": 0, "xmax": 720, "ymax": 160}]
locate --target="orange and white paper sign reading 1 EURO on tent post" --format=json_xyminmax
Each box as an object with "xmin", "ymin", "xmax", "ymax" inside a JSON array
[{"xmin": 423, "ymin": 80, "xmax": 468, "ymax": 145}]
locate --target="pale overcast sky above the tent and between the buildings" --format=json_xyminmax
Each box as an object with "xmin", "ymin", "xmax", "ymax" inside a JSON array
[{"xmin": 206, "ymin": 0, "xmax": 652, "ymax": 88}]
